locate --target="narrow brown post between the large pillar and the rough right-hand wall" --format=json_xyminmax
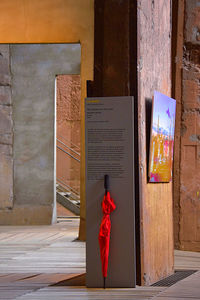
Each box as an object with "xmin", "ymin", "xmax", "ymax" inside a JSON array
[{"xmin": 172, "ymin": 0, "xmax": 185, "ymax": 249}]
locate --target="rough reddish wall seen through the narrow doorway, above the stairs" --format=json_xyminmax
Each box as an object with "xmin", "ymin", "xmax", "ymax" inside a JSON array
[{"xmin": 57, "ymin": 75, "xmax": 81, "ymax": 191}]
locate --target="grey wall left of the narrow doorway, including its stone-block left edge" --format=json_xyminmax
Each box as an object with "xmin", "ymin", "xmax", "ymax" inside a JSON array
[{"xmin": 0, "ymin": 44, "xmax": 81, "ymax": 225}]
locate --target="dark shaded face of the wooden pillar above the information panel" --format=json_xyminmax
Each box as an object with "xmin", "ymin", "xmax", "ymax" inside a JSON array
[{"xmin": 88, "ymin": 0, "xmax": 134, "ymax": 97}]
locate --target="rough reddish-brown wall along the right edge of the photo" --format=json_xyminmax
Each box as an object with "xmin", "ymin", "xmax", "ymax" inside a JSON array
[{"xmin": 179, "ymin": 0, "xmax": 200, "ymax": 251}]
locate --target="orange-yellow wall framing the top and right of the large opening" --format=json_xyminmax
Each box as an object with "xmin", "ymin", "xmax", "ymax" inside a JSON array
[{"xmin": 0, "ymin": 0, "xmax": 94, "ymax": 227}]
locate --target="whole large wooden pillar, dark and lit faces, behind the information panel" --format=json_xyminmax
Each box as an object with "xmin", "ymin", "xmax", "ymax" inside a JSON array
[{"xmin": 88, "ymin": 0, "xmax": 173, "ymax": 285}]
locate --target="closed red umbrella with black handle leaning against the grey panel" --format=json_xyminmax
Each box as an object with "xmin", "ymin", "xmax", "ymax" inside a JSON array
[{"xmin": 99, "ymin": 175, "xmax": 116, "ymax": 288}]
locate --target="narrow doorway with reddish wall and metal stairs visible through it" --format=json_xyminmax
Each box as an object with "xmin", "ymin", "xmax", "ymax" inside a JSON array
[{"xmin": 56, "ymin": 75, "xmax": 81, "ymax": 221}]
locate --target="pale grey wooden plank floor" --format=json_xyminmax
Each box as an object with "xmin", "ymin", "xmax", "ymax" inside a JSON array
[{"xmin": 0, "ymin": 217, "xmax": 200, "ymax": 300}]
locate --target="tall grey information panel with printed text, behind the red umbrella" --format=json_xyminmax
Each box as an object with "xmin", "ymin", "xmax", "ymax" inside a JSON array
[{"xmin": 85, "ymin": 97, "xmax": 135, "ymax": 287}]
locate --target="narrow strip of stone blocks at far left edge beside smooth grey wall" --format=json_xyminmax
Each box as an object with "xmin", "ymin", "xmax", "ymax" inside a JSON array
[{"xmin": 0, "ymin": 45, "xmax": 13, "ymax": 209}]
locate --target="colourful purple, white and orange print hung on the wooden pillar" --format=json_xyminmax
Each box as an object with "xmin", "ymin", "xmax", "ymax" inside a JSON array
[{"xmin": 149, "ymin": 91, "xmax": 176, "ymax": 182}]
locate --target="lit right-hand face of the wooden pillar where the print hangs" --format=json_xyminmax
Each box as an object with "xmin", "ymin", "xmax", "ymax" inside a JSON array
[{"xmin": 137, "ymin": 0, "xmax": 173, "ymax": 285}]
